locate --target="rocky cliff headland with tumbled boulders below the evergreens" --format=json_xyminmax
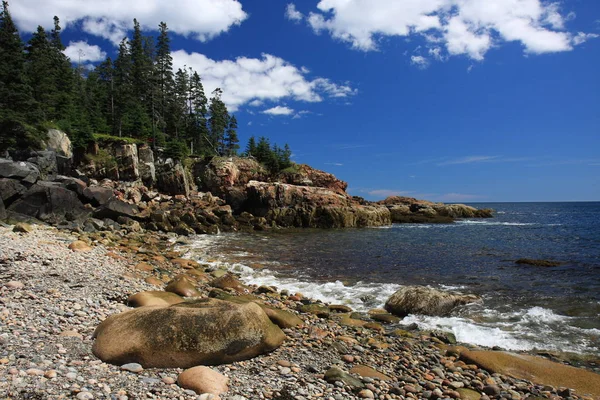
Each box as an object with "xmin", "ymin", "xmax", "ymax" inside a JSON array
[{"xmin": 0, "ymin": 131, "xmax": 491, "ymax": 234}]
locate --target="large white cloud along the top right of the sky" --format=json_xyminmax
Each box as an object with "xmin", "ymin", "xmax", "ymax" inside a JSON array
[{"xmin": 307, "ymin": 0, "xmax": 591, "ymax": 61}]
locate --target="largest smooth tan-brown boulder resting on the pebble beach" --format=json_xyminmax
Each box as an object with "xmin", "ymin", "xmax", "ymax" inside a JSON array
[{"xmin": 92, "ymin": 299, "xmax": 285, "ymax": 368}]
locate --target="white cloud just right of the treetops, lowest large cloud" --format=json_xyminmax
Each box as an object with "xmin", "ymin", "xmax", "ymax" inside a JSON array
[{"xmin": 173, "ymin": 50, "xmax": 356, "ymax": 111}]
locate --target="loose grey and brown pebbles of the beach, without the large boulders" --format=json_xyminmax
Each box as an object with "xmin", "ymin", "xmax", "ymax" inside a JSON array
[{"xmin": 0, "ymin": 226, "xmax": 600, "ymax": 400}]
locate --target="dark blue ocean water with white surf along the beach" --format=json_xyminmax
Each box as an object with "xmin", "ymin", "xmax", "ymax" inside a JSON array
[{"xmin": 183, "ymin": 202, "xmax": 600, "ymax": 355}]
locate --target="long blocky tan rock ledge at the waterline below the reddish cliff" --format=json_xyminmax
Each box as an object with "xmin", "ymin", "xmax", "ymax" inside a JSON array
[{"xmin": 246, "ymin": 181, "xmax": 391, "ymax": 228}]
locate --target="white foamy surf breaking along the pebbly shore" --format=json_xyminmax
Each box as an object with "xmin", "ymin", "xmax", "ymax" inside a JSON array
[{"xmin": 180, "ymin": 234, "xmax": 600, "ymax": 354}]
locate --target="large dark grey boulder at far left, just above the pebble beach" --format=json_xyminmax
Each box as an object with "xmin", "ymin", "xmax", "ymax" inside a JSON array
[{"xmin": 8, "ymin": 182, "xmax": 88, "ymax": 223}]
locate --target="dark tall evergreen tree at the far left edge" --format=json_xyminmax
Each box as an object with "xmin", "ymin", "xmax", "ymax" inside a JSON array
[{"xmin": 0, "ymin": 1, "xmax": 42, "ymax": 122}]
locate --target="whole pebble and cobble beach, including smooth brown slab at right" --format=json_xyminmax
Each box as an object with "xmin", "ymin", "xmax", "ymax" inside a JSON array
[{"xmin": 0, "ymin": 225, "xmax": 600, "ymax": 400}]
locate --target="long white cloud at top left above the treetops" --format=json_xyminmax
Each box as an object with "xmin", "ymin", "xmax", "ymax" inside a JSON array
[{"xmin": 10, "ymin": 0, "xmax": 248, "ymax": 43}]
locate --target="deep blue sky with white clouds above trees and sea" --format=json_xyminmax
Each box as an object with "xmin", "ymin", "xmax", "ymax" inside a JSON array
[{"xmin": 9, "ymin": 0, "xmax": 600, "ymax": 202}]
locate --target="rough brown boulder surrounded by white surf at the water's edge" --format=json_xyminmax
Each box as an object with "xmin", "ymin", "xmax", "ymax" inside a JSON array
[{"xmin": 385, "ymin": 286, "xmax": 481, "ymax": 317}]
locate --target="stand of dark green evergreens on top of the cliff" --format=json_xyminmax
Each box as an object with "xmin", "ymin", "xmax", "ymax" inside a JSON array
[{"xmin": 0, "ymin": 1, "xmax": 251, "ymax": 158}]
